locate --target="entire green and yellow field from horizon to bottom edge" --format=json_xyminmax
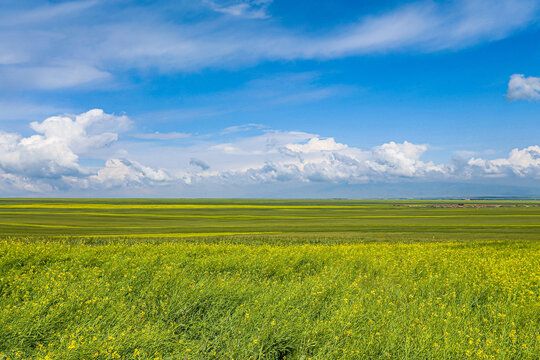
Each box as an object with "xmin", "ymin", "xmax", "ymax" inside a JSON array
[{"xmin": 0, "ymin": 199, "xmax": 540, "ymax": 359}]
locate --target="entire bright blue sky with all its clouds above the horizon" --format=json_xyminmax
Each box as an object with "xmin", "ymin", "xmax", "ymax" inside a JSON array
[{"xmin": 0, "ymin": 0, "xmax": 540, "ymax": 197}]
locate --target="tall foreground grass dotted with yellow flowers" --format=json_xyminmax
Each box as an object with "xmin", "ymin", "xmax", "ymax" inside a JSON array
[{"xmin": 0, "ymin": 235, "xmax": 540, "ymax": 360}]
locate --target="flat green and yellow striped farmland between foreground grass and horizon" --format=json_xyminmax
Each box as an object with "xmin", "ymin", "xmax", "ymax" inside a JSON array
[{"xmin": 0, "ymin": 199, "xmax": 540, "ymax": 240}]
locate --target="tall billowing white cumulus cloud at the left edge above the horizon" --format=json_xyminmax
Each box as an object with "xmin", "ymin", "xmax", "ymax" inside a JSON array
[{"xmin": 0, "ymin": 109, "xmax": 166, "ymax": 191}]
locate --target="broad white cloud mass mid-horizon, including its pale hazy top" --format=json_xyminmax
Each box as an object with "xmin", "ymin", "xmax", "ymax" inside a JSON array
[{"xmin": 180, "ymin": 136, "xmax": 442, "ymax": 183}]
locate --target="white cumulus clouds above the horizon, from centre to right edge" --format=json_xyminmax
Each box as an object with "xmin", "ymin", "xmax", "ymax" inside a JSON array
[{"xmin": 189, "ymin": 133, "xmax": 540, "ymax": 184}]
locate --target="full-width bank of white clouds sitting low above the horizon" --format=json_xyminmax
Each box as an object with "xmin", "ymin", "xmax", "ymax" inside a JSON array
[{"xmin": 0, "ymin": 109, "xmax": 540, "ymax": 194}]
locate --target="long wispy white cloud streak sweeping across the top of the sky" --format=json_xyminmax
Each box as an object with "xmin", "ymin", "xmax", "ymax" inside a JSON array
[{"xmin": 0, "ymin": 0, "xmax": 539, "ymax": 89}]
